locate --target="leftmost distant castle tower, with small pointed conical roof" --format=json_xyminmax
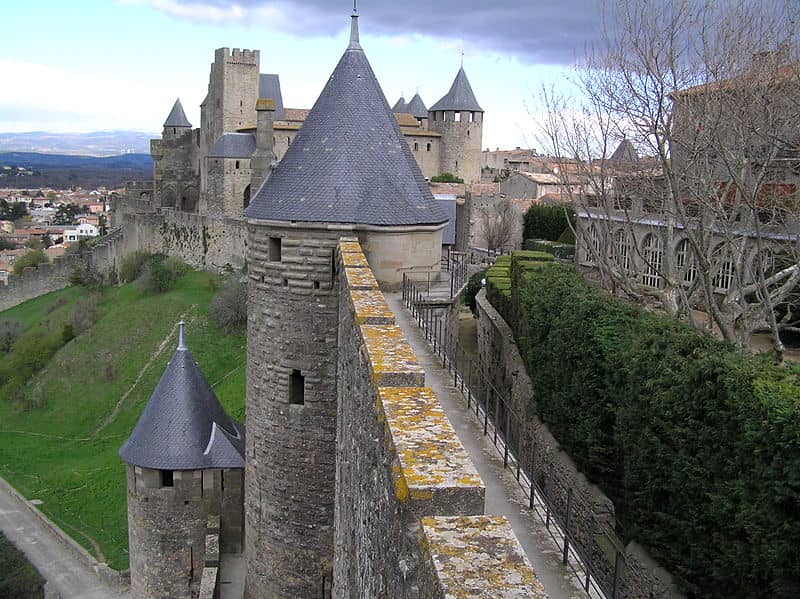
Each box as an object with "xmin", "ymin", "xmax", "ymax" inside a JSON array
[{"xmin": 150, "ymin": 98, "xmax": 199, "ymax": 212}]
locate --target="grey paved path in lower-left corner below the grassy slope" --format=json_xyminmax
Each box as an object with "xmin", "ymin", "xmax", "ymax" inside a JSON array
[{"xmin": 0, "ymin": 478, "xmax": 130, "ymax": 599}]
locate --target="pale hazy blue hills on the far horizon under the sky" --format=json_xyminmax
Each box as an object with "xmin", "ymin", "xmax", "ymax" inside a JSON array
[{"xmin": 0, "ymin": 131, "xmax": 158, "ymax": 156}]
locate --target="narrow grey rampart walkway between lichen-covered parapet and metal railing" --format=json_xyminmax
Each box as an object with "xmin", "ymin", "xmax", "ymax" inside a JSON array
[{"xmin": 384, "ymin": 293, "xmax": 586, "ymax": 599}]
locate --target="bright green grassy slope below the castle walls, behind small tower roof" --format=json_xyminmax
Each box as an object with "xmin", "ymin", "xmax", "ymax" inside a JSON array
[{"xmin": 0, "ymin": 273, "xmax": 245, "ymax": 569}]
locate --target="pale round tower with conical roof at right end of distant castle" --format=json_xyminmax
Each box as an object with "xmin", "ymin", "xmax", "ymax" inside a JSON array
[{"xmin": 428, "ymin": 66, "xmax": 483, "ymax": 183}]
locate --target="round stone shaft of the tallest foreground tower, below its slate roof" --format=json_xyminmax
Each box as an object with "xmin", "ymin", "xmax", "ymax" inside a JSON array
[{"xmin": 245, "ymin": 223, "xmax": 339, "ymax": 599}]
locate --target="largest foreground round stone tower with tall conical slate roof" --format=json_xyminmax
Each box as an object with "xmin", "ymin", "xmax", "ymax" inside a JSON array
[{"xmin": 244, "ymin": 13, "xmax": 447, "ymax": 599}]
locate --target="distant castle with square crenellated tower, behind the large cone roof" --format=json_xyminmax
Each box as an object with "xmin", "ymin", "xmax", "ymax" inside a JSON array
[{"xmin": 141, "ymin": 38, "xmax": 483, "ymax": 224}]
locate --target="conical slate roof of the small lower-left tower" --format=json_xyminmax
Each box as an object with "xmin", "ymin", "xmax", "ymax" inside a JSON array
[{"xmin": 119, "ymin": 323, "xmax": 244, "ymax": 470}]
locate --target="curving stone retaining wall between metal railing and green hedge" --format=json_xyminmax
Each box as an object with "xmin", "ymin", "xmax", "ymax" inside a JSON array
[{"xmin": 476, "ymin": 291, "xmax": 680, "ymax": 599}]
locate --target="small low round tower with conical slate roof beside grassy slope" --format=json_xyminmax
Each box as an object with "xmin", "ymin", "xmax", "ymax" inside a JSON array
[{"xmin": 119, "ymin": 323, "xmax": 244, "ymax": 599}]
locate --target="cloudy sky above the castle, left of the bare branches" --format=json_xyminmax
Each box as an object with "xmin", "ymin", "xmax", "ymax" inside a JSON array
[{"xmin": 0, "ymin": 0, "xmax": 600, "ymax": 148}]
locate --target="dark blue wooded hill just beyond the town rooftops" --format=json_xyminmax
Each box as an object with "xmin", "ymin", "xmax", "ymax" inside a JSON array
[{"xmin": 0, "ymin": 152, "xmax": 153, "ymax": 189}]
